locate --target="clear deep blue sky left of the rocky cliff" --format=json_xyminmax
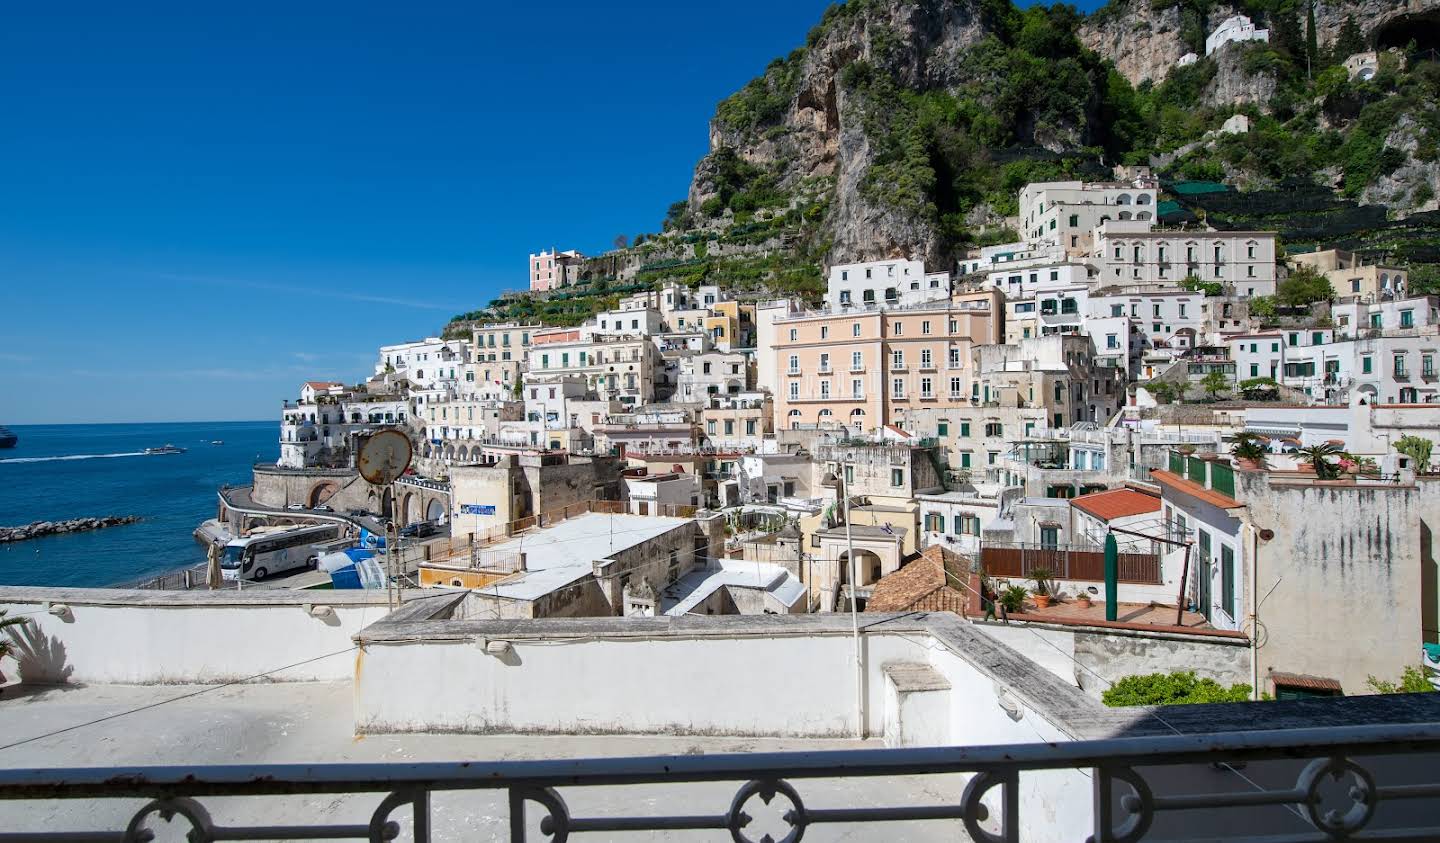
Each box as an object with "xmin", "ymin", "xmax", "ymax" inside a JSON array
[{"xmin": 0, "ymin": 0, "xmax": 1100, "ymax": 424}]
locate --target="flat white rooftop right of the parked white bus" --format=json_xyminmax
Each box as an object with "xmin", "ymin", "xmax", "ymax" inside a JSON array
[{"xmin": 484, "ymin": 512, "xmax": 691, "ymax": 599}]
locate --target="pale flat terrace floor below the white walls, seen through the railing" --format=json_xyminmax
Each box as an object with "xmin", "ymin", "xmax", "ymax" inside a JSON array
[{"xmin": 0, "ymin": 682, "xmax": 968, "ymax": 840}]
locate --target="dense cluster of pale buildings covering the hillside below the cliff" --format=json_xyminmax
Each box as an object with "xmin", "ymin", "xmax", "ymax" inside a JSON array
[{"xmin": 244, "ymin": 161, "xmax": 1440, "ymax": 697}]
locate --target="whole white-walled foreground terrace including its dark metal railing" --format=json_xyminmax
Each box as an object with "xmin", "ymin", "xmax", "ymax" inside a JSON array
[{"xmin": 0, "ymin": 588, "xmax": 1440, "ymax": 842}]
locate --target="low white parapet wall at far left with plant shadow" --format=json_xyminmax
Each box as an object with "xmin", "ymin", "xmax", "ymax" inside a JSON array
[{"xmin": 0, "ymin": 586, "xmax": 389, "ymax": 684}]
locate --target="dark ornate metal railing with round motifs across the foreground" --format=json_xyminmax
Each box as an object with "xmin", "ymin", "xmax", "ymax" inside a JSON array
[{"xmin": 0, "ymin": 723, "xmax": 1440, "ymax": 843}]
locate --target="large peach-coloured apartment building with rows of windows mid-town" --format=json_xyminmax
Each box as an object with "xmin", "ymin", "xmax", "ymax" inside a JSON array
[{"xmin": 773, "ymin": 290, "xmax": 1002, "ymax": 429}]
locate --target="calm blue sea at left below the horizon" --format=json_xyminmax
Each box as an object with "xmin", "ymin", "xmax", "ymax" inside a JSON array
[{"xmin": 0, "ymin": 419, "xmax": 279, "ymax": 586}]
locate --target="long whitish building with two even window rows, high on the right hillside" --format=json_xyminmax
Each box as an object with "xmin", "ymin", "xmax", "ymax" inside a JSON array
[{"xmin": 1094, "ymin": 220, "xmax": 1276, "ymax": 295}]
